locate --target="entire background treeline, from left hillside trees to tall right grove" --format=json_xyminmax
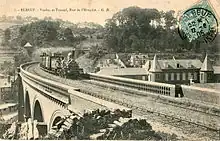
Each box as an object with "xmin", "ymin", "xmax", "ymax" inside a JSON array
[{"xmin": 2, "ymin": 7, "xmax": 219, "ymax": 53}]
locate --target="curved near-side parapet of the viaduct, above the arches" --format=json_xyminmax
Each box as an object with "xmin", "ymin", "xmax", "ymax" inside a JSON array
[{"xmin": 20, "ymin": 62, "xmax": 130, "ymax": 113}]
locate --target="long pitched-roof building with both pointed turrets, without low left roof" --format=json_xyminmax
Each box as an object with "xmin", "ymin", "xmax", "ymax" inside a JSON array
[{"xmin": 144, "ymin": 55, "xmax": 218, "ymax": 84}]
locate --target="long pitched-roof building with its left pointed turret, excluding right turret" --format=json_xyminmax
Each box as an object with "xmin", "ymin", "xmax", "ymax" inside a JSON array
[{"xmin": 144, "ymin": 55, "xmax": 202, "ymax": 84}]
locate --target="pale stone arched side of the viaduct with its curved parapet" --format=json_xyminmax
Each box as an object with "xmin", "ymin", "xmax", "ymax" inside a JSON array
[{"xmin": 18, "ymin": 63, "xmax": 129, "ymax": 133}]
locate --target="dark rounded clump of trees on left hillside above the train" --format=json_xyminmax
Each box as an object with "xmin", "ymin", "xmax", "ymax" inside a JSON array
[{"xmin": 19, "ymin": 20, "xmax": 85, "ymax": 46}]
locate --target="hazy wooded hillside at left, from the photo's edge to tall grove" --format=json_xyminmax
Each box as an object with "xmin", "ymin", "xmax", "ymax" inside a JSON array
[{"xmin": 0, "ymin": 18, "xmax": 103, "ymax": 48}]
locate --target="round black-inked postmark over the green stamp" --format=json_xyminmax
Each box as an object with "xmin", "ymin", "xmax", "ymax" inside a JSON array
[{"xmin": 178, "ymin": 8, "xmax": 218, "ymax": 43}]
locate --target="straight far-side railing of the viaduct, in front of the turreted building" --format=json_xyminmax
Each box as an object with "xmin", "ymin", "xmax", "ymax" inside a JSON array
[{"xmin": 89, "ymin": 73, "xmax": 175, "ymax": 97}]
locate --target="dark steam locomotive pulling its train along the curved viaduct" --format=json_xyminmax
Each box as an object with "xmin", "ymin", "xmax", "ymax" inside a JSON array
[{"xmin": 40, "ymin": 50, "xmax": 88, "ymax": 79}]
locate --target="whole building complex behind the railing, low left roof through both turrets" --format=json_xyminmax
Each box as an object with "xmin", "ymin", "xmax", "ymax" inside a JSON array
[{"xmin": 97, "ymin": 55, "xmax": 220, "ymax": 84}]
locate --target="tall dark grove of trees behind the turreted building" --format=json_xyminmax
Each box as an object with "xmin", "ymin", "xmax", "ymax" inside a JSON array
[{"xmin": 105, "ymin": 7, "xmax": 217, "ymax": 52}]
